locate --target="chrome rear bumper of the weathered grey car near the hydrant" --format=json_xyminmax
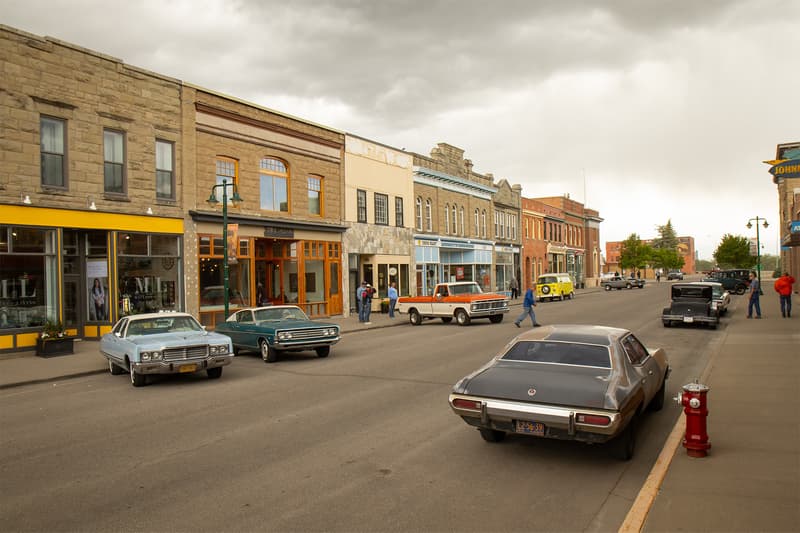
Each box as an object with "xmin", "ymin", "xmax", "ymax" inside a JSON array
[{"xmin": 450, "ymin": 393, "xmax": 624, "ymax": 443}]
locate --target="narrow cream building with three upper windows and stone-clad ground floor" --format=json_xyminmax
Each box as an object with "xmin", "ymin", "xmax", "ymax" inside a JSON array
[{"xmin": 342, "ymin": 134, "xmax": 416, "ymax": 315}]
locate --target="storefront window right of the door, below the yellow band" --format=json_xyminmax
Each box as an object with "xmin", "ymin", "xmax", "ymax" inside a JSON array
[{"xmin": 118, "ymin": 233, "xmax": 182, "ymax": 316}]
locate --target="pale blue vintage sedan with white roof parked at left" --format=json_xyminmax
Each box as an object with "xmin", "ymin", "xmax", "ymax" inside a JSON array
[{"xmin": 100, "ymin": 313, "xmax": 233, "ymax": 387}]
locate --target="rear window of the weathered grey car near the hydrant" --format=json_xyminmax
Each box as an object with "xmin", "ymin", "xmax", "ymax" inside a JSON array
[{"xmin": 502, "ymin": 341, "xmax": 611, "ymax": 368}]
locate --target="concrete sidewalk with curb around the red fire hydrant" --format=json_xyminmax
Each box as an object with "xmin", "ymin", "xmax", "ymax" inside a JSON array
[{"xmin": 621, "ymin": 297, "xmax": 800, "ymax": 532}]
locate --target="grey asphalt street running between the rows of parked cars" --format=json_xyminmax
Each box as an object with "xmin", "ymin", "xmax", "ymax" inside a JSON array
[{"xmin": 0, "ymin": 283, "xmax": 725, "ymax": 531}]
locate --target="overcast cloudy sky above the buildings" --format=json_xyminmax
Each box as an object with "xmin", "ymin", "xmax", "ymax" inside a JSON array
[{"xmin": 0, "ymin": 0, "xmax": 800, "ymax": 259}]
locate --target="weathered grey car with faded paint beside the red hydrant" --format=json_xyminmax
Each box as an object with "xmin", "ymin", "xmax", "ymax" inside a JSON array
[{"xmin": 449, "ymin": 325, "xmax": 670, "ymax": 460}]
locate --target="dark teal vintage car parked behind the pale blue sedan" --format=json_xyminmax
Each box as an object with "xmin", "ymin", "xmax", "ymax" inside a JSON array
[{"xmin": 216, "ymin": 305, "xmax": 341, "ymax": 363}]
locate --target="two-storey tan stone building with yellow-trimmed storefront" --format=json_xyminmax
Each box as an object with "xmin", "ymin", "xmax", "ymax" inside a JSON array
[{"xmin": 0, "ymin": 26, "xmax": 185, "ymax": 351}]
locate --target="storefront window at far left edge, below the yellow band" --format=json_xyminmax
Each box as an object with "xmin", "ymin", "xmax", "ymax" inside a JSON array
[{"xmin": 0, "ymin": 225, "xmax": 58, "ymax": 329}]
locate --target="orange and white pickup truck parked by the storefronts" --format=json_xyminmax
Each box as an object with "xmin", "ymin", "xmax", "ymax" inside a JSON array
[{"xmin": 395, "ymin": 281, "xmax": 508, "ymax": 326}]
